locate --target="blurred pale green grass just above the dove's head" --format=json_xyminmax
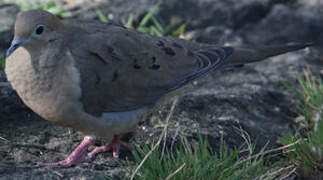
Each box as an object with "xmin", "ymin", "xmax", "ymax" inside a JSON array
[{"xmin": 16, "ymin": 0, "xmax": 72, "ymax": 19}]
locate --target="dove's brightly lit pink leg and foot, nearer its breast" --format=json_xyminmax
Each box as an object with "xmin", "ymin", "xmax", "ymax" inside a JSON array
[{"xmin": 37, "ymin": 136, "xmax": 95, "ymax": 167}]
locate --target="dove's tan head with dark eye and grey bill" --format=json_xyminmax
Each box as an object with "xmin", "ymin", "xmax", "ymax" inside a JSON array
[{"xmin": 6, "ymin": 10, "xmax": 62, "ymax": 57}]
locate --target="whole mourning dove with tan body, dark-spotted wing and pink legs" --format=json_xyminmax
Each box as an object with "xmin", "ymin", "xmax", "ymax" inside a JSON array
[{"xmin": 5, "ymin": 10, "xmax": 310, "ymax": 167}]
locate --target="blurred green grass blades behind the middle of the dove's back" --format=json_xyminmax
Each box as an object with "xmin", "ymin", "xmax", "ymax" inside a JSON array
[{"xmin": 95, "ymin": 1, "xmax": 187, "ymax": 37}]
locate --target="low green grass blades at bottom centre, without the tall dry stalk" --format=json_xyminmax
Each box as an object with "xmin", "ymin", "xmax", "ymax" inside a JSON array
[{"xmin": 133, "ymin": 136, "xmax": 270, "ymax": 180}]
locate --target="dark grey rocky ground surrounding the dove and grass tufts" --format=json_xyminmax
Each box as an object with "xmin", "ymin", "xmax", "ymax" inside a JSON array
[{"xmin": 0, "ymin": 0, "xmax": 323, "ymax": 179}]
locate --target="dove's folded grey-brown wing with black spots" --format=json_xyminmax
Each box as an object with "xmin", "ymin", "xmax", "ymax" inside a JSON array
[{"xmin": 69, "ymin": 24, "xmax": 233, "ymax": 116}]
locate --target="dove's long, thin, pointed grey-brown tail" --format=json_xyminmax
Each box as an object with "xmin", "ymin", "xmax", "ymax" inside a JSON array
[{"xmin": 225, "ymin": 43, "xmax": 313, "ymax": 67}]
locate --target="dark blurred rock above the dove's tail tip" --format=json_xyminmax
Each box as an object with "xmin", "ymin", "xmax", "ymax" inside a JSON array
[{"xmin": 237, "ymin": 5, "xmax": 323, "ymax": 44}]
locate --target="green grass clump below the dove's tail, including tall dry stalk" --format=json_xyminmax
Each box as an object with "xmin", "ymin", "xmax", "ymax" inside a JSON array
[{"xmin": 117, "ymin": 102, "xmax": 280, "ymax": 180}]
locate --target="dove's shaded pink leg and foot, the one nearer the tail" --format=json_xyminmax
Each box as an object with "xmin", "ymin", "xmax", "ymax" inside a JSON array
[{"xmin": 81, "ymin": 135, "xmax": 131, "ymax": 162}]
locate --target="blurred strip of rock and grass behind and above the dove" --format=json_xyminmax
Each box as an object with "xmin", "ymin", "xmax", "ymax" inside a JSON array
[{"xmin": 0, "ymin": 0, "xmax": 323, "ymax": 55}]
